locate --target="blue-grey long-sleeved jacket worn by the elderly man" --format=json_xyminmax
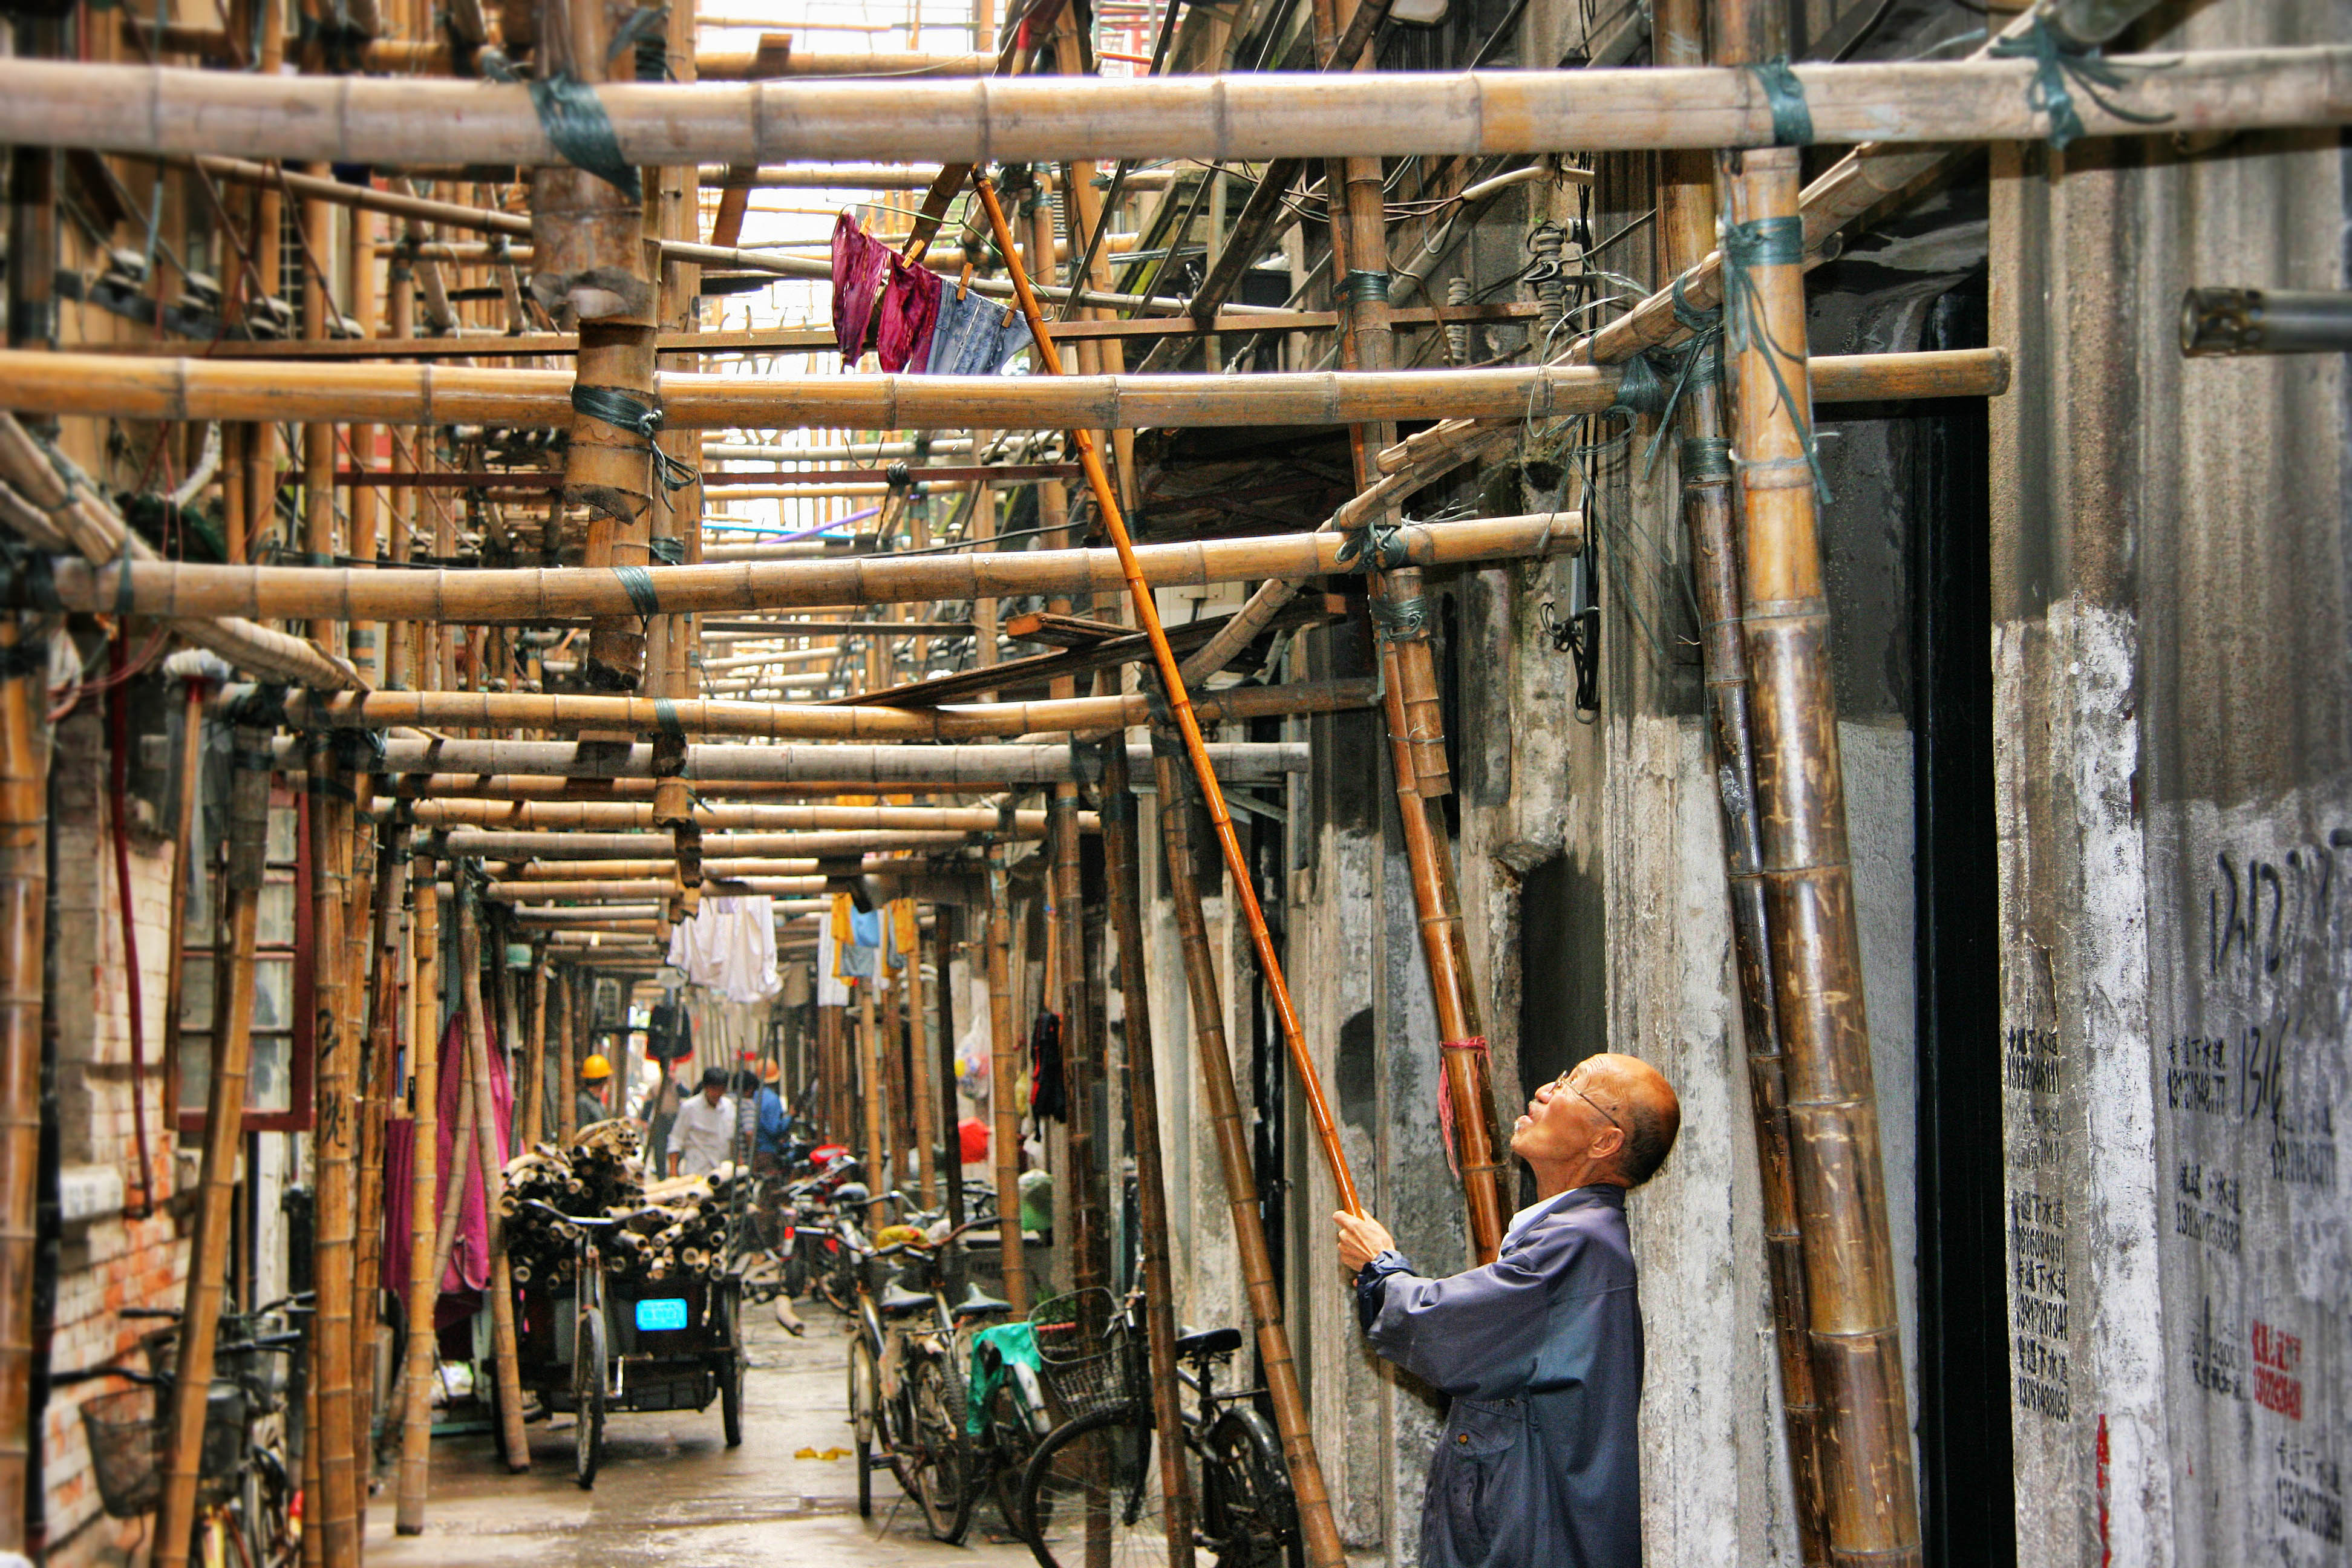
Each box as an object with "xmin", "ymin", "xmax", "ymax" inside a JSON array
[{"xmin": 1357, "ymin": 1185, "xmax": 1642, "ymax": 1568}]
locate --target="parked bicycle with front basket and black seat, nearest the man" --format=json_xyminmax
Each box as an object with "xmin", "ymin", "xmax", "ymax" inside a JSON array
[{"xmin": 1021, "ymin": 1290, "xmax": 1301, "ymax": 1568}]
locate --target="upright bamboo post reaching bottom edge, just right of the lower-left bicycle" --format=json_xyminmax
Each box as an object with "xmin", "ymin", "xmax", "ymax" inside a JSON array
[{"xmin": 305, "ymin": 733, "xmax": 360, "ymax": 1568}]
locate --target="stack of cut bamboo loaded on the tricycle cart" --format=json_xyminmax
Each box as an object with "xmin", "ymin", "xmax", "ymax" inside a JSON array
[{"xmin": 501, "ymin": 1122, "xmax": 734, "ymax": 1284}]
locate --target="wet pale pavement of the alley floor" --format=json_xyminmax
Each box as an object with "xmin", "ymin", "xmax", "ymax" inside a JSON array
[{"xmin": 367, "ymin": 1302, "xmax": 1030, "ymax": 1568}]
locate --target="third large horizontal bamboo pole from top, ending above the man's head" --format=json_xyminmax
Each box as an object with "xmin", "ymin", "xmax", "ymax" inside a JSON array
[{"xmin": 22, "ymin": 515, "xmax": 1583, "ymax": 620}]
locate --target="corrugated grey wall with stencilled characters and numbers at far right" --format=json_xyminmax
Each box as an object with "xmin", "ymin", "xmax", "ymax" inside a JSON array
[{"xmin": 1992, "ymin": 0, "xmax": 2352, "ymax": 1568}]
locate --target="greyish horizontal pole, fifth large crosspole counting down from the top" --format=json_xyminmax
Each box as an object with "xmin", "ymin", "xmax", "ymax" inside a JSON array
[{"xmin": 298, "ymin": 738, "xmax": 1308, "ymax": 794}]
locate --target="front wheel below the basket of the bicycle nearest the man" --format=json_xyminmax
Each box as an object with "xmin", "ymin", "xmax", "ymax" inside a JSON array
[{"xmin": 1021, "ymin": 1406, "xmax": 1169, "ymax": 1568}]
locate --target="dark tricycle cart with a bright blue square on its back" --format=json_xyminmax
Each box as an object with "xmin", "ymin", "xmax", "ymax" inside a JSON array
[{"xmin": 517, "ymin": 1204, "xmax": 743, "ymax": 1486}]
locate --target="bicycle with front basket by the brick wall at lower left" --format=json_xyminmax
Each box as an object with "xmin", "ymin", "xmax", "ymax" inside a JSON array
[{"xmin": 52, "ymin": 1298, "xmax": 308, "ymax": 1568}]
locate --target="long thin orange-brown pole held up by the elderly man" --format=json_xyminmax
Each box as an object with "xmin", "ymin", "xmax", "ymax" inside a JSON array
[{"xmin": 972, "ymin": 174, "xmax": 1364, "ymax": 1222}]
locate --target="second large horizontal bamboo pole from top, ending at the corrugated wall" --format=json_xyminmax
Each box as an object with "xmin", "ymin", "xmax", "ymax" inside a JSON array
[{"xmin": 0, "ymin": 348, "xmax": 2008, "ymax": 430}]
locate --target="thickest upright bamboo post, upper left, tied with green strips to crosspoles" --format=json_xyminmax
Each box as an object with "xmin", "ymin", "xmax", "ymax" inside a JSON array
[{"xmin": 532, "ymin": 0, "xmax": 661, "ymax": 691}]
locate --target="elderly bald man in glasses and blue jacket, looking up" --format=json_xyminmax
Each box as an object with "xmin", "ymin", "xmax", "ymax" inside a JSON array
[{"xmin": 1331, "ymin": 1056, "xmax": 1682, "ymax": 1568}]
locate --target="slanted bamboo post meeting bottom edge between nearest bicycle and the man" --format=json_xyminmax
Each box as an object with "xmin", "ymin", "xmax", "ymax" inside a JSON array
[{"xmin": 1152, "ymin": 733, "xmax": 1348, "ymax": 1568}]
